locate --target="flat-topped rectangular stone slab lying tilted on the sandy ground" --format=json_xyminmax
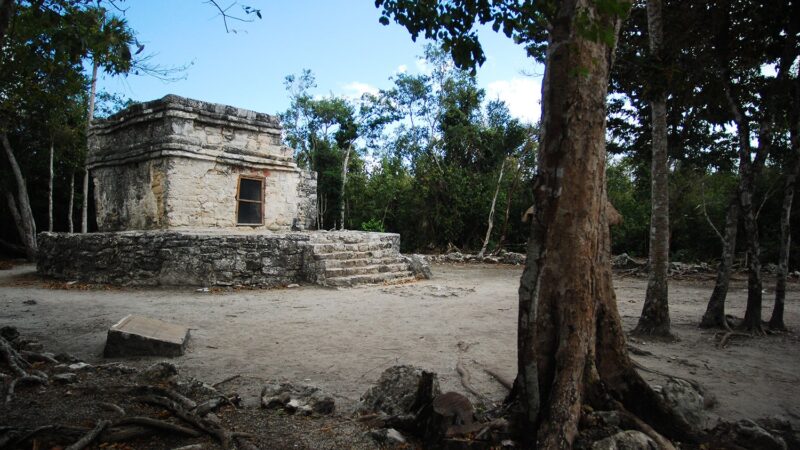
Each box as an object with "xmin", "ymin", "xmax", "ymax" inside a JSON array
[{"xmin": 103, "ymin": 314, "xmax": 189, "ymax": 358}]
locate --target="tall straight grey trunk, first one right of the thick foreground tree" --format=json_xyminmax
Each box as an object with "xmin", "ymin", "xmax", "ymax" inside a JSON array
[{"xmin": 634, "ymin": 0, "xmax": 670, "ymax": 336}]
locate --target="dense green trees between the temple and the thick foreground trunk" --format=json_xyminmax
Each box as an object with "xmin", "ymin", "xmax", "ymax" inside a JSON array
[{"xmin": 281, "ymin": 47, "xmax": 536, "ymax": 251}]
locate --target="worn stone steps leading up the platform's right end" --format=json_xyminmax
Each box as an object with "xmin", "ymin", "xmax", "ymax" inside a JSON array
[{"xmin": 310, "ymin": 231, "xmax": 415, "ymax": 287}]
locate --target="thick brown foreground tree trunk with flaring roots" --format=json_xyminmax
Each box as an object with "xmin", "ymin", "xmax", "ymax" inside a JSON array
[{"xmin": 514, "ymin": 0, "xmax": 693, "ymax": 449}]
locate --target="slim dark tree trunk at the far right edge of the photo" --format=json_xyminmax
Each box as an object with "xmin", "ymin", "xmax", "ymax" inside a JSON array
[{"xmin": 769, "ymin": 78, "xmax": 800, "ymax": 330}]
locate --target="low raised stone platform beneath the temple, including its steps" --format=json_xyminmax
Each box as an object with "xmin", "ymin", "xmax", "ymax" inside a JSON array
[{"xmin": 37, "ymin": 230, "xmax": 415, "ymax": 287}]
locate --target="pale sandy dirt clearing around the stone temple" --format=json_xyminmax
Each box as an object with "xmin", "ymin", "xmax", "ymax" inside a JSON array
[{"xmin": 0, "ymin": 265, "xmax": 800, "ymax": 425}]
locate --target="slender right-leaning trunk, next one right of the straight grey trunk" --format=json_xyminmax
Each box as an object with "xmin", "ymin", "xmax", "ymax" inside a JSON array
[{"xmin": 700, "ymin": 191, "xmax": 739, "ymax": 328}]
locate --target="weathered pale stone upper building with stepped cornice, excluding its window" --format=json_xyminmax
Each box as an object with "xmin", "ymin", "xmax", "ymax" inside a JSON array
[{"xmin": 87, "ymin": 95, "xmax": 316, "ymax": 231}]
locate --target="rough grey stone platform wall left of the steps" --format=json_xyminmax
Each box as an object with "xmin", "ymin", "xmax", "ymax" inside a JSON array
[{"xmin": 37, "ymin": 231, "xmax": 318, "ymax": 287}]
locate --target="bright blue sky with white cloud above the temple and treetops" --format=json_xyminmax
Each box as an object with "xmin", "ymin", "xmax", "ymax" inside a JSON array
[{"xmin": 99, "ymin": 0, "xmax": 543, "ymax": 121}]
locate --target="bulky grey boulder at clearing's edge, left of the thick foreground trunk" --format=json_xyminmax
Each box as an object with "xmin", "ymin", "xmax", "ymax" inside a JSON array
[{"xmin": 359, "ymin": 365, "xmax": 441, "ymax": 416}]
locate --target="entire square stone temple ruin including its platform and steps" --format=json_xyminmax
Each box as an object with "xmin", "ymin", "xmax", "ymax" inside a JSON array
[{"xmin": 37, "ymin": 95, "xmax": 418, "ymax": 286}]
